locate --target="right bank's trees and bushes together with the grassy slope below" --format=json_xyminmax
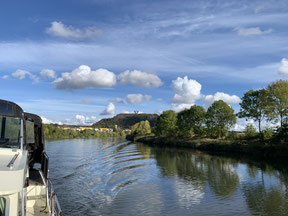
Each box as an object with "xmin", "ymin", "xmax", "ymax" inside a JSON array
[{"xmin": 127, "ymin": 80, "xmax": 288, "ymax": 156}]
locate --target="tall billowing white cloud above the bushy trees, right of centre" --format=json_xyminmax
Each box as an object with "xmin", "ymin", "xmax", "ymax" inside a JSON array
[{"xmin": 171, "ymin": 76, "xmax": 202, "ymax": 112}]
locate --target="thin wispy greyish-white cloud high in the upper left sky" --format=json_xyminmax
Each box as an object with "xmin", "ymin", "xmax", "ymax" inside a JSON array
[{"xmin": 46, "ymin": 21, "xmax": 101, "ymax": 39}]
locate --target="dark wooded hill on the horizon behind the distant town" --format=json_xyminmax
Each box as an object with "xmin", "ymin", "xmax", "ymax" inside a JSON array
[{"xmin": 92, "ymin": 114, "xmax": 158, "ymax": 129}]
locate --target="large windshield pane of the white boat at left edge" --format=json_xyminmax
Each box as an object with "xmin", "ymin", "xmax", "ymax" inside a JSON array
[{"xmin": 0, "ymin": 116, "xmax": 21, "ymax": 148}]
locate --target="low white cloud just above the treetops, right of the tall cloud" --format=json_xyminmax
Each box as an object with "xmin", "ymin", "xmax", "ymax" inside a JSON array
[{"xmin": 203, "ymin": 92, "xmax": 241, "ymax": 106}]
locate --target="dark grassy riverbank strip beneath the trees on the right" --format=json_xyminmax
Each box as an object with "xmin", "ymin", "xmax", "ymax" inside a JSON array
[{"xmin": 126, "ymin": 135, "xmax": 288, "ymax": 158}]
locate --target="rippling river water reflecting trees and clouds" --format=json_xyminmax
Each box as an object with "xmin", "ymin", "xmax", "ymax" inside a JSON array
[{"xmin": 46, "ymin": 138, "xmax": 288, "ymax": 216}]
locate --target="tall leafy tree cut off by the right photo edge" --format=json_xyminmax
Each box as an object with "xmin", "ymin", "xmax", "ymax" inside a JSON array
[{"xmin": 267, "ymin": 80, "xmax": 288, "ymax": 128}]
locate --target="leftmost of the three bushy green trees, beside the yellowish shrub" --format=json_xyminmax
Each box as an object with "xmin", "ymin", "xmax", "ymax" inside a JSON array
[{"xmin": 155, "ymin": 110, "xmax": 177, "ymax": 136}]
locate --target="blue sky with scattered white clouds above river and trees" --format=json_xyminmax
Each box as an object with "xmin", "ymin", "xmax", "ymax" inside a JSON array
[{"xmin": 0, "ymin": 0, "xmax": 288, "ymax": 129}]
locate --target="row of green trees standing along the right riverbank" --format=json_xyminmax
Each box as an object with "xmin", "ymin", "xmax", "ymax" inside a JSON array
[{"xmin": 153, "ymin": 80, "xmax": 288, "ymax": 139}]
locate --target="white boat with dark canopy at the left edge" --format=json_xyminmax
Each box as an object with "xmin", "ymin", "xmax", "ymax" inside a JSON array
[{"xmin": 0, "ymin": 100, "xmax": 62, "ymax": 216}]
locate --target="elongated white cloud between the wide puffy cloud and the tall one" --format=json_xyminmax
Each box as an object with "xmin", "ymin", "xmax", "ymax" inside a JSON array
[{"xmin": 118, "ymin": 70, "xmax": 163, "ymax": 88}]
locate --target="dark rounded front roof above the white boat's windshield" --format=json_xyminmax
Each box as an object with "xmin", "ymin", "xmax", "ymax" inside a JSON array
[{"xmin": 0, "ymin": 99, "xmax": 24, "ymax": 118}]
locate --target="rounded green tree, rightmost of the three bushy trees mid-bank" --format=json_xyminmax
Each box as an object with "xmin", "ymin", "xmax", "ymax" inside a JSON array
[{"xmin": 206, "ymin": 100, "xmax": 236, "ymax": 137}]
